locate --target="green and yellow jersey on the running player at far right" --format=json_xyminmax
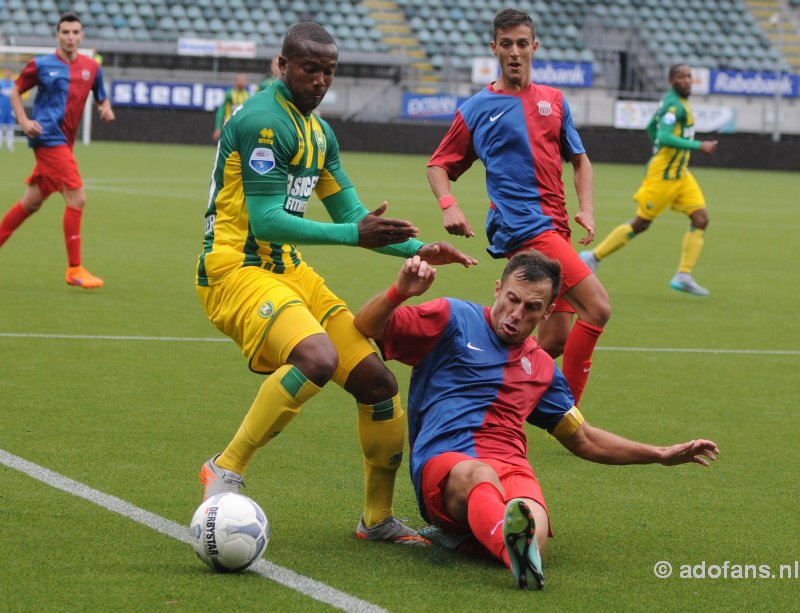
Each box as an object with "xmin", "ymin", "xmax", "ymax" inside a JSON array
[{"xmin": 647, "ymin": 89, "xmax": 700, "ymax": 179}]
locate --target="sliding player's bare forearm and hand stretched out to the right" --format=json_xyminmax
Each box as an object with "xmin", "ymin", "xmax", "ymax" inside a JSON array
[{"xmin": 561, "ymin": 422, "xmax": 719, "ymax": 466}]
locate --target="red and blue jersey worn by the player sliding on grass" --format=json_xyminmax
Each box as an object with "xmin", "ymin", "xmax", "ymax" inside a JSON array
[{"xmin": 381, "ymin": 298, "xmax": 575, "ymax": 516}]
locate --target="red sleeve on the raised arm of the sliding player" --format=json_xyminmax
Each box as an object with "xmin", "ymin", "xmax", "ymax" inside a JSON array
[{"xmin": 378, "ymin": 298, "xmax": 450, "ymax": 366}]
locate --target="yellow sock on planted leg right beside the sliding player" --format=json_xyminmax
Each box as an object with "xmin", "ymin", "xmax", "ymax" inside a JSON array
[{"xmin": 358, "ymin": 394, "xmax": 406, "ymax": 528}]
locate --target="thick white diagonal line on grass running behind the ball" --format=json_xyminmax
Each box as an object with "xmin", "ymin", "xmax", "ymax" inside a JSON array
[{"xmin": 0, "ymin": 449, "xmax": 387, "ymax": 613}]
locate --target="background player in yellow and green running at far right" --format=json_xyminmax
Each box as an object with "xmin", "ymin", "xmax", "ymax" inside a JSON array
[{"xmin": 581, "ymin": 64, "xmax": 717, "ymax": 296}]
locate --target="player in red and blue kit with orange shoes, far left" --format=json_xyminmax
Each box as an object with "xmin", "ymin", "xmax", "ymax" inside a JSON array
[{"xmin": 0, "ymin": 13, "xmax": 114, "ymax": 289}]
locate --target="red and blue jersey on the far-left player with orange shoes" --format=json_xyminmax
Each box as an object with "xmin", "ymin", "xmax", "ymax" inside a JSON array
[{"xmin": 17, "ymin": 53, "xmax": 106, "ymax": 148}]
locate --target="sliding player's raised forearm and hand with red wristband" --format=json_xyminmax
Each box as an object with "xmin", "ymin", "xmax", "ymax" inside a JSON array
[{"xmin": 354, "ymin": 255, "xmax": 436, "ymax": 340}]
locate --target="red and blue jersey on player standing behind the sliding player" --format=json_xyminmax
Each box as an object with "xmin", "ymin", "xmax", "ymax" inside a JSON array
[{"xmin": 428, "ymin": 83, "xmax": 586, "ymax": 258}]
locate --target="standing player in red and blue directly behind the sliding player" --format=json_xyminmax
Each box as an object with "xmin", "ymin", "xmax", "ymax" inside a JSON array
[{"xmin": 428, "ymin": 9, "xmax": 611, "ymax": 401}]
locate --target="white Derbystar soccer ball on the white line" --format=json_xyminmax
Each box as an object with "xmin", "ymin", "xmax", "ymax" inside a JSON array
[{"xmin": 190, "ymin": 492, "xmax": 269, "ymax": 573}]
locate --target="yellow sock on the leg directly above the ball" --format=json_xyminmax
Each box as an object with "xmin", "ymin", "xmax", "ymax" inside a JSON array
[{"xmin": 216, "ymin": 364, "xmax": 321, "ymax": 475}]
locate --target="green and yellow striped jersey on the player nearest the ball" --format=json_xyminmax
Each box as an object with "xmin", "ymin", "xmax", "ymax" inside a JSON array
[{"xmin": 195, "ymin": 80, "xmax": 354, "ymax": 285}]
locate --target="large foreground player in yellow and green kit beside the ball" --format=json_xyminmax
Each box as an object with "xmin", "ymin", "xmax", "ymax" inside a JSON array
[{"xmin": 196, "ymin": 22, "xmax": 477, "ymax": 544}]
